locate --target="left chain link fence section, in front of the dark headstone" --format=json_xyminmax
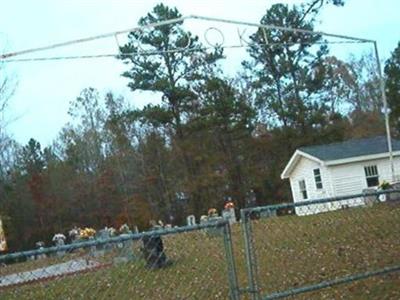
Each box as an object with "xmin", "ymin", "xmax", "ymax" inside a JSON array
[{"xmin": 0, "ymin": 221, "xmax": 238, "ymax": 299}]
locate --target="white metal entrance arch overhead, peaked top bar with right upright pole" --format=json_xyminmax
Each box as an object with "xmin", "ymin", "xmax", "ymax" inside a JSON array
[{"xmin": 0, "ymin": 15, "xmax": 396, "ymax": 182}]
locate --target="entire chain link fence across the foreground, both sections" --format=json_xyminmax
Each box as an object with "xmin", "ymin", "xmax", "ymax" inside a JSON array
[{"xmin": 0, "ymin": 191, "xmax": 400, "ymax": 300}]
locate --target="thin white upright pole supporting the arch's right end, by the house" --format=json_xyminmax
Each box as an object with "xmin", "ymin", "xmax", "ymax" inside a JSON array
[{"xmin": 373, "ymin": 41, "xmax": 396, "ymax": 182}]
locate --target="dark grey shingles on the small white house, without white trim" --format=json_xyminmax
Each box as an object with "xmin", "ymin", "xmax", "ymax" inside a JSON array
[{"xmin": 299, "ymin": 136, "xmax": 400, "ymax": 161}]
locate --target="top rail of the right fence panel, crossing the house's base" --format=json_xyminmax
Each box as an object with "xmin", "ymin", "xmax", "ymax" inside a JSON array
[{"xmin": 241, "ymin": 189, "xmax": 400, "ymax": 216}]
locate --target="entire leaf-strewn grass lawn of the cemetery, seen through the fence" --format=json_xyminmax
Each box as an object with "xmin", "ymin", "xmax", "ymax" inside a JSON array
[{"xmin": 0, "ymin": 204, "xmax": 400, "ymax": 299}]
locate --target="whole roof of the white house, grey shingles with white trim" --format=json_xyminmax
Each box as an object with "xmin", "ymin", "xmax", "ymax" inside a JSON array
[{"xmin": 281, "ymin": 136, "xmax": 400, "ymax": 179}]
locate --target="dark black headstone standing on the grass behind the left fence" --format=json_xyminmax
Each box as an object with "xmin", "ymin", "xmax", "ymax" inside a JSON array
[{"xmin": 142, "ymin": 235, "xmax": 171, "ymax": 269}]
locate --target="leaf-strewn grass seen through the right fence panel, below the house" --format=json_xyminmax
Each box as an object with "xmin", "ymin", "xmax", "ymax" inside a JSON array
[{"xmin": 247, "ymin": 204, "xmax": 400, "ymax": 299}]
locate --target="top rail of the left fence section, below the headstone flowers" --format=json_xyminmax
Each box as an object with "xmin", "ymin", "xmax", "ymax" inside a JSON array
[{"xmin": 0, "ymin": 219, "xmax": 229, "ymax": 263}]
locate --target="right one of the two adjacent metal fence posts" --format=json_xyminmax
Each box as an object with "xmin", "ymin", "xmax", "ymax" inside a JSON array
[{"xmin": 240, "ymin": 209, "xmax": 260, "ymax": 300}]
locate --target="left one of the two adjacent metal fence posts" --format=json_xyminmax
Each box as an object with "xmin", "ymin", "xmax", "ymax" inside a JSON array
[{"xmin": 223, "ymin": 222, "xmax": 240, "ymax": 300}]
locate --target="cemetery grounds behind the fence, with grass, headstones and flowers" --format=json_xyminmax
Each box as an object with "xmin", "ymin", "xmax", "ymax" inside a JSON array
[{"xmin": 0, "ymin": 198, "xmax": 400, "ymax": 299}]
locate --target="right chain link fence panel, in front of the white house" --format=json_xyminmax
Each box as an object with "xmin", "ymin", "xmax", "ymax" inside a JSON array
[{"xmin": 242, "ymin": 191, "xmax": 400, "ymax": 299}]
